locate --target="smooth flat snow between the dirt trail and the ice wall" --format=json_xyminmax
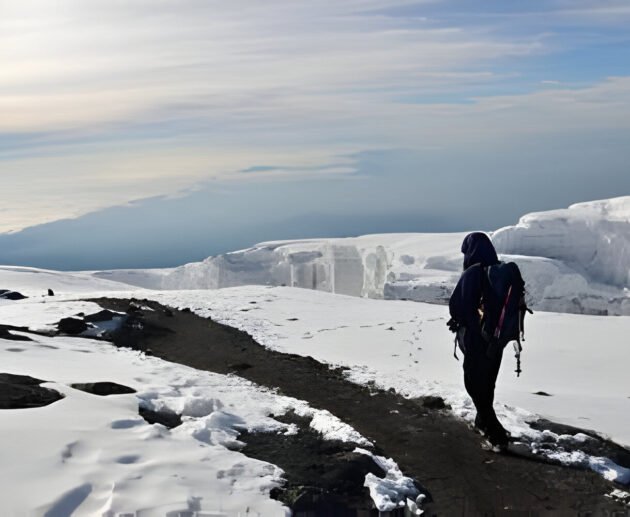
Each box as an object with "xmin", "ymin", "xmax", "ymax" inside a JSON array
[{"xmin": 143, "ymin": 286, "xmax": 630, "ymax": 482}]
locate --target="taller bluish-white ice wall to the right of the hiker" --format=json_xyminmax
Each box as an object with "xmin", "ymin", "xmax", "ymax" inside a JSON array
[{"xmin": 492, "ymin": 196, "xmax": 630, "ymax": 314}]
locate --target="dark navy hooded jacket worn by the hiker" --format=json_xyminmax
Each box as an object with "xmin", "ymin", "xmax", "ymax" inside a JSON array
[{"xmin": 449, "ymin": 232, "xmax": 499, "ymax": 338}]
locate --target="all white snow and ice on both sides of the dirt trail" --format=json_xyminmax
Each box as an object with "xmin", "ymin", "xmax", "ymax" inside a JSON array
[{"xmin": 0, "ymin": 197, "xmax": 630, "ymax": 515}]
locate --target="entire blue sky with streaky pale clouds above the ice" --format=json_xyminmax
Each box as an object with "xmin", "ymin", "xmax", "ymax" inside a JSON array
[{"xmin": 0, "ymin": 0, "xmax": 630, "ymax": 269}]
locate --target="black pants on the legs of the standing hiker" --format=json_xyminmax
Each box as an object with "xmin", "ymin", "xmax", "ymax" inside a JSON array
[{"xmin": 464, "ymin": 336, "xmax": 507, "ymax": 441}]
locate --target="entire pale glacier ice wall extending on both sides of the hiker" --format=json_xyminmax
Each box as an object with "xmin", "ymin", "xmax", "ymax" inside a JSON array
[{"xmin": 95, "ymin": 196, "xmax": 630, "ymax": 315}]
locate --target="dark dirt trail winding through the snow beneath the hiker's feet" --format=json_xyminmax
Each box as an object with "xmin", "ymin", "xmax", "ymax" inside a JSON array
[{"xmin": 93, "ymin": 299, "xmax": 630, "ymax": 516}]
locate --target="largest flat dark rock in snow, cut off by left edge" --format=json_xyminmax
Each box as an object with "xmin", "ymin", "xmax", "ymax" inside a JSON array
[{"xmin": 0, "ymin": 373, "xmax": 63, "ymax": 409}]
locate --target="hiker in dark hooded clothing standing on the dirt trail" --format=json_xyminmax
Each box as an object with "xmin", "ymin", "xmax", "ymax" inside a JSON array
[{"xmin": 448, "ymin": 232, "xmax": 524, "ymax": 448}]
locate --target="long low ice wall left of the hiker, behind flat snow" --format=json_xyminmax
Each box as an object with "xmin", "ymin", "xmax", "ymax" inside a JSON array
[{"xmin": 156, "ymin": 234, "xmax": 463, "ymax": 302}]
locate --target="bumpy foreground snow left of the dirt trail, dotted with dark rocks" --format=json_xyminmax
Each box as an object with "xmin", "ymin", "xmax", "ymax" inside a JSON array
[{"xmin": 0, "ymin": 293, "xmax": 420, "ymax": 517}]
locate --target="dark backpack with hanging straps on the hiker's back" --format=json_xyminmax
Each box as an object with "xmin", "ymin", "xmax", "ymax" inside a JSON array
[{"xmin": 481, "ymin": 262, "xmax": 532, "ymax": 374}]
